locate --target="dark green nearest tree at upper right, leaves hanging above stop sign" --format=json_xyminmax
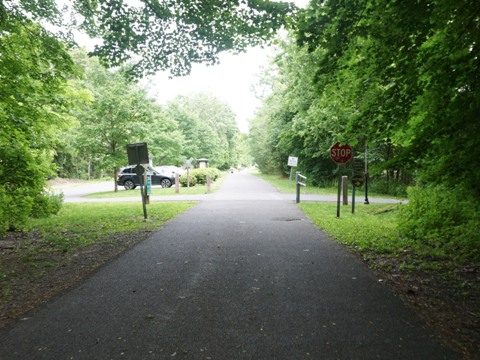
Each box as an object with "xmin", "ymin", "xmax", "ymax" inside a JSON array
[{"xmin": 297, "ymin": 0, "xmax": 480, "ymax": 196}]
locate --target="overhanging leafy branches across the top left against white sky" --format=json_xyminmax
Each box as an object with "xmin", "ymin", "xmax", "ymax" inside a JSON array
[{"xmin": 0, "ymin": 0, "xmax": 296, "ymax": 77}]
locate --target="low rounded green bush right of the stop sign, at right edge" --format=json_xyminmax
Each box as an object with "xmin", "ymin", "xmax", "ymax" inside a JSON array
[{"xmin": 399, "ymin": 185, "xmax": 480, "ymax": 259}]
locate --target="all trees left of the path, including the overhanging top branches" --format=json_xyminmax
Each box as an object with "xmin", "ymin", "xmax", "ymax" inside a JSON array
[{"xmin": 0, "ymin": 0, "xmax": 289, "ymax": 232}]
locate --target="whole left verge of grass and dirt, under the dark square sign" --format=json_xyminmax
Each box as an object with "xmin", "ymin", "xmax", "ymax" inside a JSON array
[{"xmin": 0, "ymin": 202, "xmax": 196, "ymax": 327}]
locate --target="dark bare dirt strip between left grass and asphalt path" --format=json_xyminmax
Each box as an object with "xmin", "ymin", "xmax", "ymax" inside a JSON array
[{"xmin": 0, "ymin": 231, "xmax": 151, "ymax": 327}]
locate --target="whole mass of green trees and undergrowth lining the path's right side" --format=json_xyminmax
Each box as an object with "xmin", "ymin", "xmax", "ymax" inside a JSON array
[{"xmin": 251, "ymin": 0, "xmax": 480, "ymax": 256}]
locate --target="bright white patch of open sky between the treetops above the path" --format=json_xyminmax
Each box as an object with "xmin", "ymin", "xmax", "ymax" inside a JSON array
[{"xmin": 144, "ymin": 0, "xmax": 309, "ymax": 133}]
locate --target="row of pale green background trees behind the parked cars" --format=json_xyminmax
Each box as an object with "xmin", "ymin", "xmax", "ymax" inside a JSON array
[{"xmin": 55, "ymin": 50, "xmax": 241, "ymax": 184}]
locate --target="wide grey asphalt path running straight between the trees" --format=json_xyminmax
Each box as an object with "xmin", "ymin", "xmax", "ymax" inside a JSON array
[{"xmin": 0, "ymin": 173, "xmax": 459, "ymax": 360}]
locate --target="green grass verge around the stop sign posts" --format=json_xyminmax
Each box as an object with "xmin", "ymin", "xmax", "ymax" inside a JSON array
[{"xmin": 298, "ymin": 202, "xmax": 471, "ymax": 270}]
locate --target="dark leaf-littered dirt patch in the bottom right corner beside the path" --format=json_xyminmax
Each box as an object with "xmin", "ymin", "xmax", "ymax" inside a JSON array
[{"xmin": 367, "ymin": 255, "xmax": 480, "ymax": 360}]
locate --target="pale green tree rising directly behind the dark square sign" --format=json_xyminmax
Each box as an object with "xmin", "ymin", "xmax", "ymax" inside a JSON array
[{"xmin": 70, "ymin": 53, "xmax": 159, "ymax": 190}]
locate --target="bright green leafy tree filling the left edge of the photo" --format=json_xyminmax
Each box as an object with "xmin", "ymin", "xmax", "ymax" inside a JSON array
[{"xmin": 0, "ymin": 12, "xmax": 73, "ymax": 232}]
